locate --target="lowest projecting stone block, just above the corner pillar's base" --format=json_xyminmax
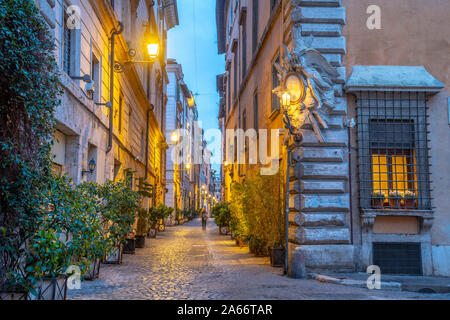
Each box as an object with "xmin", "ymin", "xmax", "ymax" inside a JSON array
[{"xmin": 295, "ymin": 227, "xmax": 350, "ymax": 244}]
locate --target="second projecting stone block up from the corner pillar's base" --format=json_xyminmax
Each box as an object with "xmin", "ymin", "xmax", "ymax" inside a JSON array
[{"xmin": 289, "ymin": 193, "xmax": 350, "ymax": 212}]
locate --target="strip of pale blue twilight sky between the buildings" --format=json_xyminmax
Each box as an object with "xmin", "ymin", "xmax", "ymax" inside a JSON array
[{"xmin": 167, "ymin": 0, "xmax": 225, "ymax": 164}]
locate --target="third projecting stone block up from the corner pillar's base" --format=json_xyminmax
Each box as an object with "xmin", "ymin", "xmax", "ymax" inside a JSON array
[{"xmin": 294, "ymin": 162, "xmax": 348, "ymax": 180}]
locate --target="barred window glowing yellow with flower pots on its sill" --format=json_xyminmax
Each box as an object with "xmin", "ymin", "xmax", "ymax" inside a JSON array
[{"xmin": 357, "ymin": 92, "xmax": 431, "ymax": 210}]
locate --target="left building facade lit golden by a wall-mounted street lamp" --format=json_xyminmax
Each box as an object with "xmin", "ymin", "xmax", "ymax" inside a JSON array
[{"xmin": 36, "ymin": 0, "xmax": 178, "ymax": 206}]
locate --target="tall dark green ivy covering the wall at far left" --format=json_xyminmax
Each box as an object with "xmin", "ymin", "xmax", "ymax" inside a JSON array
[{"xmin": 0, "ymin": 0, "xmax": 61, "ymax": 291}]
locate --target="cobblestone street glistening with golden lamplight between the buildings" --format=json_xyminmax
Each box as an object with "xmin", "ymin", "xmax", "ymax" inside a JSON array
[{"xmin": 68, "ymin": 220, "xmax": 450, "ymax": 300}]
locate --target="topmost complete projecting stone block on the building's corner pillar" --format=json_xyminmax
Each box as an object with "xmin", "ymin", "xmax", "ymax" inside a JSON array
[{"xmin": 291, "ymin": 7, "xmax": 346, "ymax": 24}]
